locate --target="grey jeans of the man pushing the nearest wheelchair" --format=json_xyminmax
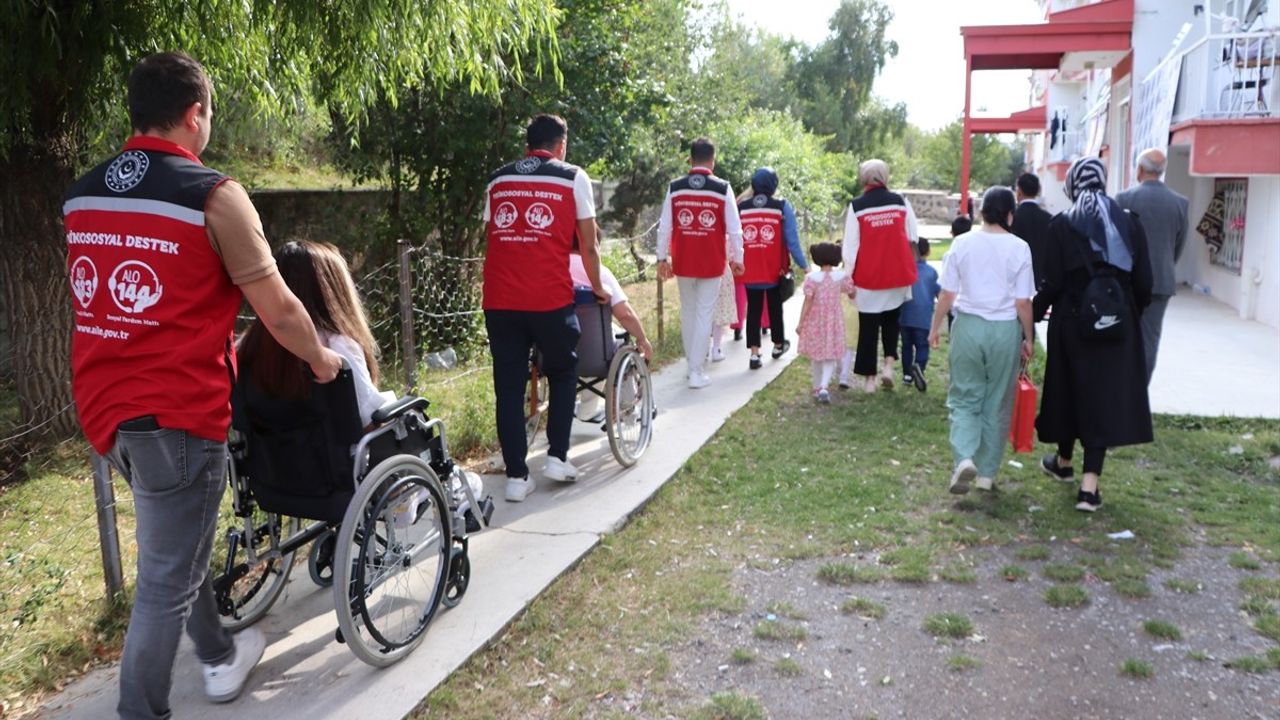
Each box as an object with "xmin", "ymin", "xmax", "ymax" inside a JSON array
[{"xmin": 106, "ymin": 428, "xmax": 236, "ymax": 720}]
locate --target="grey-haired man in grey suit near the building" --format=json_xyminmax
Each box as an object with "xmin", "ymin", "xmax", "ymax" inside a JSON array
[{"xmin": 1116, "ymin": 149, "xmax": 1187, "ymax": 383}]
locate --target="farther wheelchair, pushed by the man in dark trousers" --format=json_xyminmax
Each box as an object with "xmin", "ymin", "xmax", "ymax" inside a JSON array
[{"xmin": 525, "ymin": 288, "xmax": 657, "ymax": 468}]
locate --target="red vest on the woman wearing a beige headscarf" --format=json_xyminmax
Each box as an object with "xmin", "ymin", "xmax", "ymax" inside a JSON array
[{"xmin": 850, "ymin": 186, "xmax": 918, "ymax": 290}]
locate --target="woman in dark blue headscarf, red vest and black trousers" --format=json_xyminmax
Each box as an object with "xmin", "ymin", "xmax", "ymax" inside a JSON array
[{"xmin": 737, "ymin": 168, "xmax": 809, "ymax": 370}]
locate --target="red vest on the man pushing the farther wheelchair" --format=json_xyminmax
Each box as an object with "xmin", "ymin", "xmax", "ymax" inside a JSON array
[{"xmin": 484, "ymin": 150, "xmax": 581, "ymax": 313}]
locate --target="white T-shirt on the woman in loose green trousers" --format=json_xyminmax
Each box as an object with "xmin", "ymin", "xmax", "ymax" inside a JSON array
[{"xmin": 942, "ymin": 229, "xmax": 1036, "ymax": 322}]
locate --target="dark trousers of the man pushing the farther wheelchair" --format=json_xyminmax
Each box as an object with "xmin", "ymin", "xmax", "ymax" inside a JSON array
[{"xmin": 484, "ymin": 305, "xmax": 581, "ymax": 478}]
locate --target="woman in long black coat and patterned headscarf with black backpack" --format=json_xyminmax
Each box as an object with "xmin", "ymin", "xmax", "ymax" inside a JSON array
[{"xmin": 1033, "ymin": 158, "xmax": 1152, "ymax": 512}]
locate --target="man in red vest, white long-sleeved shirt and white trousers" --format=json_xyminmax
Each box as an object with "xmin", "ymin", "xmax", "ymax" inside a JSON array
[{"xmin": 658, "ymin": 137, "xmax": 742, "ymax": 388}]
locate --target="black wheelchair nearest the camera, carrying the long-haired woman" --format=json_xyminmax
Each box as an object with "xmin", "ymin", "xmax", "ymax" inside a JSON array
[{"xmin": 210, "ymin": 368, "xmax": 494, "ymax": 667}]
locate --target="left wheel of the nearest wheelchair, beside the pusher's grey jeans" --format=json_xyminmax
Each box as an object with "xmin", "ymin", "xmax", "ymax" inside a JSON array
[{"xmin": 209, "ymin": 507, "xmax": 302, "ymax": 632}]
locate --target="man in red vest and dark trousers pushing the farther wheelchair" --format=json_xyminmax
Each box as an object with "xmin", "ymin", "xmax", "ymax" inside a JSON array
[{"xmin": 484, "ymin": 115, "xmax": 609, "ymax": 502}]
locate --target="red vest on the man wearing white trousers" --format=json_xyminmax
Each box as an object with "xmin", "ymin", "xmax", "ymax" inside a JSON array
[{"xmin": 671, "ymin": 168, "xmax": 728, "ymax": 278}]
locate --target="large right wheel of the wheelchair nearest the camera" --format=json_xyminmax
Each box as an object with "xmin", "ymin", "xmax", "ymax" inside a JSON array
[{"xmin": 333, "ymin": 455, "xmax": 453, "ymax": 667}]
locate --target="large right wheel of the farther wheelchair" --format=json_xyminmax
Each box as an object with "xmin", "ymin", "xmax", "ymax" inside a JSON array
[{"xmin": 604, "ymin": 345, "xmax": 654, "ymax": 468}]
